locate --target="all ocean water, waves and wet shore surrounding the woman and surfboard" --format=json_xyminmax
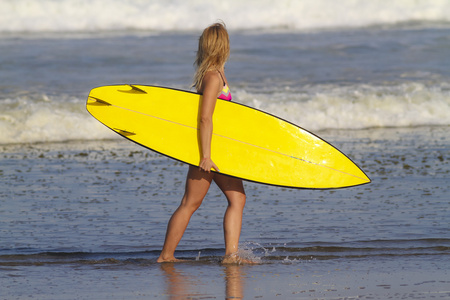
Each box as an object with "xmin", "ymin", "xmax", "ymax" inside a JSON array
[{"xmin": 0, "ymin": 0, "xmax": 450, "ymax": 299}]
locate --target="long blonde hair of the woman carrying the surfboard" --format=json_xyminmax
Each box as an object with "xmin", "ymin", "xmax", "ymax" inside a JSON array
[{"xmin": 192, "ymin": 23, "xmax": 230, "ymax": 90}]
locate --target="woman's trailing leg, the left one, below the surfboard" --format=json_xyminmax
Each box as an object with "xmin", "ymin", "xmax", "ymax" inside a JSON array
[{"xmin": 157, "ymin": 166, "xmax": 214, "ymax": 262}]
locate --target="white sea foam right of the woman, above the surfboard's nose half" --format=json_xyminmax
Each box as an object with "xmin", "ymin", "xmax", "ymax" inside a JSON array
[{"xmin": 237, "ymin": 83, "xmax": 450, "ymax": 130}]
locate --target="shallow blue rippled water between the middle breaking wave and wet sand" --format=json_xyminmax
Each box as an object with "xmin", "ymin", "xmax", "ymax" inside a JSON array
[{"xmin": 1, "ymin": 127, "xmax": 450, "ymax": 260}]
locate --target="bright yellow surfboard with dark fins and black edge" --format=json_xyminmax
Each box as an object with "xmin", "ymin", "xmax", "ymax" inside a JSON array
[{"xmin": 86, "ymin": 85, "xmax": 370, "ymax": 189}]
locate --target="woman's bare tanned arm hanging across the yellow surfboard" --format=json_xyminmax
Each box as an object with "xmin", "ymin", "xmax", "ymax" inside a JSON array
[{"xmin": 199, "ymin": 71, "xmax": 221, "ymax": 172}]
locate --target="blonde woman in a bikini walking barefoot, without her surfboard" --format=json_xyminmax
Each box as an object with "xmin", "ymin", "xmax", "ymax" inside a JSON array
[{"xmin": 157, "ymin": 23, "xmax": 245, "ymax": 263}]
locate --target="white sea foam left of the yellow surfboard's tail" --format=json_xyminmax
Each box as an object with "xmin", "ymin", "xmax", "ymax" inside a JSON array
[{"xmin": 0, "ymin": 96, "xmax": 118, "ymax": 144}]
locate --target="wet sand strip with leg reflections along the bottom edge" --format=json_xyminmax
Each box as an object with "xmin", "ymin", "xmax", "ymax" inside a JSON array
[{"xmin": 1, "ymin": 257, "xmax": 450, "ymax": 299}]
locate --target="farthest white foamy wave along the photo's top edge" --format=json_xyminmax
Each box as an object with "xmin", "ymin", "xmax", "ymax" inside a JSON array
[{"xmin": 0, "ymin": 0, "xmax": 450, "ymax": 33}]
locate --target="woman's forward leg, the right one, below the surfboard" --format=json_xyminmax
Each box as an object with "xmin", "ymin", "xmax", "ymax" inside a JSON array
[{"xmin": 214, "ymin": 174, "xmax": 246, "ymax": 256}]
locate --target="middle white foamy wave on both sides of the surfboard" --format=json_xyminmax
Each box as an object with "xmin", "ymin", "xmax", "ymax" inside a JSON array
[{"xmin": 0, "ymin": 83, "xmax": 450, "ymax": 144}]
